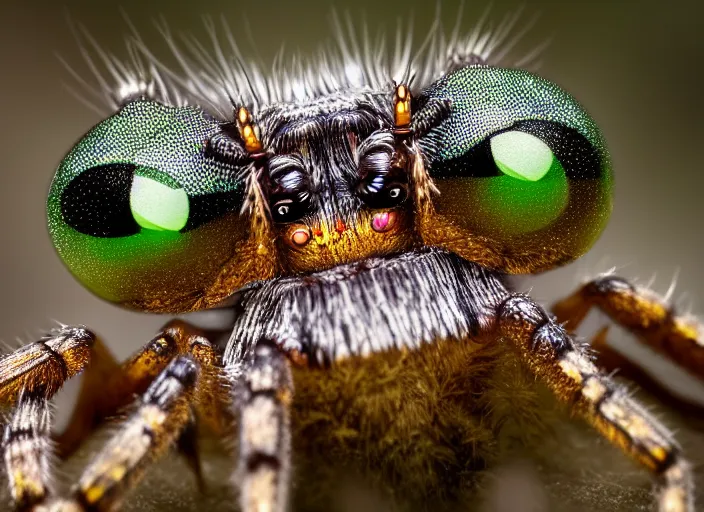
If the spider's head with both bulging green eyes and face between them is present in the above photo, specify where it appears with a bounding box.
[49,65,611,311]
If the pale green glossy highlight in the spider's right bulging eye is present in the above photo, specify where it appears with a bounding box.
[490,130,555,181]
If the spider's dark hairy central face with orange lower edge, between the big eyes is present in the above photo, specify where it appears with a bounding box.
[264,101,419,273]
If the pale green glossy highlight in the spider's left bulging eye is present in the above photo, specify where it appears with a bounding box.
[130,175,189,231]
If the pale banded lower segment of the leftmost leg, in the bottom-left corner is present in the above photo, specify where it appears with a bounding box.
[2,393,51,510]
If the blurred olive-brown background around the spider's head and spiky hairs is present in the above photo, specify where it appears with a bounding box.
[0,0,704,412]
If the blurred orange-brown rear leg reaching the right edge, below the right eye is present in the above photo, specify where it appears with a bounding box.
[553,276,704,378]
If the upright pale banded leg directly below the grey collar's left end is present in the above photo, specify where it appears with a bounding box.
[238,341,293,512]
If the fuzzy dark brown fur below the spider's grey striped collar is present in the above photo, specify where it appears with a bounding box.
[292,340,547,510]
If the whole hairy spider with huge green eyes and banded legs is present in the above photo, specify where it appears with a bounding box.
[0,5,702,511]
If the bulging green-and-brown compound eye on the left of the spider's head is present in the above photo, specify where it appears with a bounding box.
[48,100,246,309]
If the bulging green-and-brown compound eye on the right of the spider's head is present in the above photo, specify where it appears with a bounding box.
[420,66,612,272]
